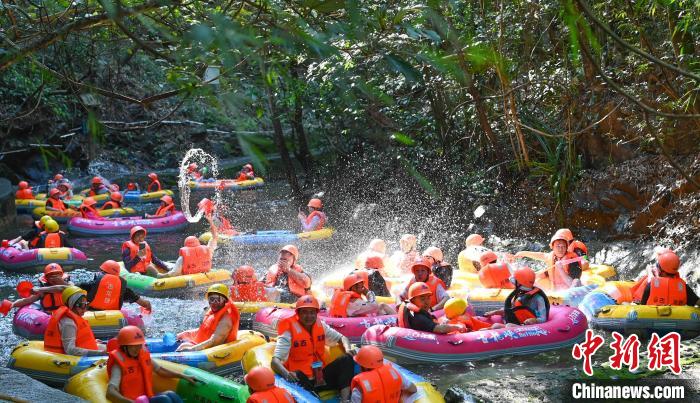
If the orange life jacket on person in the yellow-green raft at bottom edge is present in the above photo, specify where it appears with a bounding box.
[107,348,154,400]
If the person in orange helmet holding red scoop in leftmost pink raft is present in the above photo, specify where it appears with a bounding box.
[10,263,73,313]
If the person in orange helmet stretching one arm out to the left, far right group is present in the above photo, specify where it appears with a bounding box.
[515,228,588,291]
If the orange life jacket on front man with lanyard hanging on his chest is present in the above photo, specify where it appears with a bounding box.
[277,315,326,379]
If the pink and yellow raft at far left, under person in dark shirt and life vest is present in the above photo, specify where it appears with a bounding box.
[12,304,144,340]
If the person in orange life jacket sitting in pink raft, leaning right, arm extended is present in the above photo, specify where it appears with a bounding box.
[330,274,396,318]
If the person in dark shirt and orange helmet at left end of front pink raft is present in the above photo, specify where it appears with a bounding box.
[398,282,464,334]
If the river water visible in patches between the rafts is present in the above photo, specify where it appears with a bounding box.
[0,182,700,401]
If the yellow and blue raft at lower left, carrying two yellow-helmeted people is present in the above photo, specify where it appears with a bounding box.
[8,330,265,385]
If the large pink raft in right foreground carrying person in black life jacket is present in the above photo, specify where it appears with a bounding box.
[362,306,588,363]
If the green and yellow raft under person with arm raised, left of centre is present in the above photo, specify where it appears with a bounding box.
[119,262,231,297]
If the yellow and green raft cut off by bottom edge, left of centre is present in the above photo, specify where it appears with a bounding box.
[65,359,249,403]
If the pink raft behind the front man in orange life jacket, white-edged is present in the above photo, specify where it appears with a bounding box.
[253,307,398,343]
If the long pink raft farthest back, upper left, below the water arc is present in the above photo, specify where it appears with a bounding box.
[68,211,187,236]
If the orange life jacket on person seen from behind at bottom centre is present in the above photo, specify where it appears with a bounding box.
[350,363,401,403]
